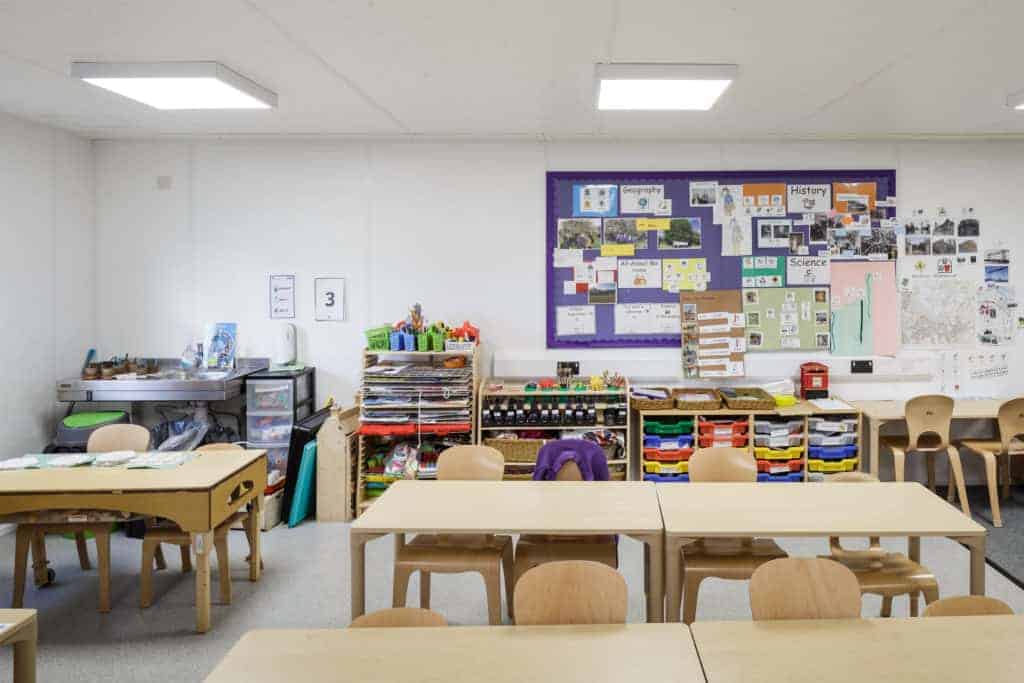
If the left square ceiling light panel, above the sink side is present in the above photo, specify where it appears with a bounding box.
[71,61,278,110]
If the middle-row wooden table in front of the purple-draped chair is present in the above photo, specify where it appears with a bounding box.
[349,481,665,622]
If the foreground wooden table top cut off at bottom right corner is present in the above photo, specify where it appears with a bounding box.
[690,616,1024,683]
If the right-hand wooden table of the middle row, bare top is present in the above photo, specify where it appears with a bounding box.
[657,481,985,622]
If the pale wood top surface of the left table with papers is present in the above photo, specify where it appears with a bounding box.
[0,450,266,496]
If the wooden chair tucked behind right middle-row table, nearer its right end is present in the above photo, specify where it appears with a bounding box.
[825,472,939,616]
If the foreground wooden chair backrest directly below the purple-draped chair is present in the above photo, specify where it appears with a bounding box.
[513,560,628,626]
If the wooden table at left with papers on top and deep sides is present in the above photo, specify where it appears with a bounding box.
[0,451,266,633]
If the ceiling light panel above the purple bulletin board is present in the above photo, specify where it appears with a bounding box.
[597,63,738,112]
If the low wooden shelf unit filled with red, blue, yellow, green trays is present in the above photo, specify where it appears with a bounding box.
[637,401,863,483]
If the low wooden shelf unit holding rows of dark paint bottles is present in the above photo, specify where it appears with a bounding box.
[476,377,632,481]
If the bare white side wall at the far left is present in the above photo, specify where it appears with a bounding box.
[0,115,95,458]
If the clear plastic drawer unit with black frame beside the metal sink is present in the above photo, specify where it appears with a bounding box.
[245,368,316,483]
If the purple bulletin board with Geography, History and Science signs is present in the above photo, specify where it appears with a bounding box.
[545,165,896,350]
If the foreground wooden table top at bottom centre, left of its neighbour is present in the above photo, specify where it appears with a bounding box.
[206,626,705,683]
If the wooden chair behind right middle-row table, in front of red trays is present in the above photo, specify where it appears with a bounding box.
[669,447,787,624]
